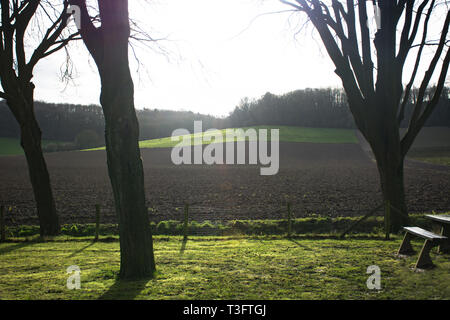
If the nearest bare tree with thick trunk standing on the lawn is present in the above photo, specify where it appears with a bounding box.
[70,0,155,278]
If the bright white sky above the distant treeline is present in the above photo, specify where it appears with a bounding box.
[34,0,446,116]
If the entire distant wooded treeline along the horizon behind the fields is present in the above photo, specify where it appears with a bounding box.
[0,88,450,149]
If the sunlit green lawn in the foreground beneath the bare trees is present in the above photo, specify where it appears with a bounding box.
[0,236,450,299]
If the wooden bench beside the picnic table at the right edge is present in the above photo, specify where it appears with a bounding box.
[398,227,447,269]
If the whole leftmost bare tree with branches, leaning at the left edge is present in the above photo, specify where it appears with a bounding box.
[0,0,77,236]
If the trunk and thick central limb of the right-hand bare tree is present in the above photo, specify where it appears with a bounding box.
[369,1,408,232]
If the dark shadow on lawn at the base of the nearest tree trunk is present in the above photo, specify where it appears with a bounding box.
[98,277,153,300]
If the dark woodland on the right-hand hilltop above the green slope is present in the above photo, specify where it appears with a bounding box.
[225,88,450,128]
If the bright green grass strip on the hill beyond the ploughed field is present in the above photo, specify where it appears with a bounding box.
[88,126,358,151]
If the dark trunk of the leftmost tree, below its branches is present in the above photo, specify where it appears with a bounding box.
[8,96,60,236]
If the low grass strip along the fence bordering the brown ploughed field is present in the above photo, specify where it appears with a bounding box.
[6,213,442,237]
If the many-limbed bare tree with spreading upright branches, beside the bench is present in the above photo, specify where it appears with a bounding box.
[280,0,450,231]
